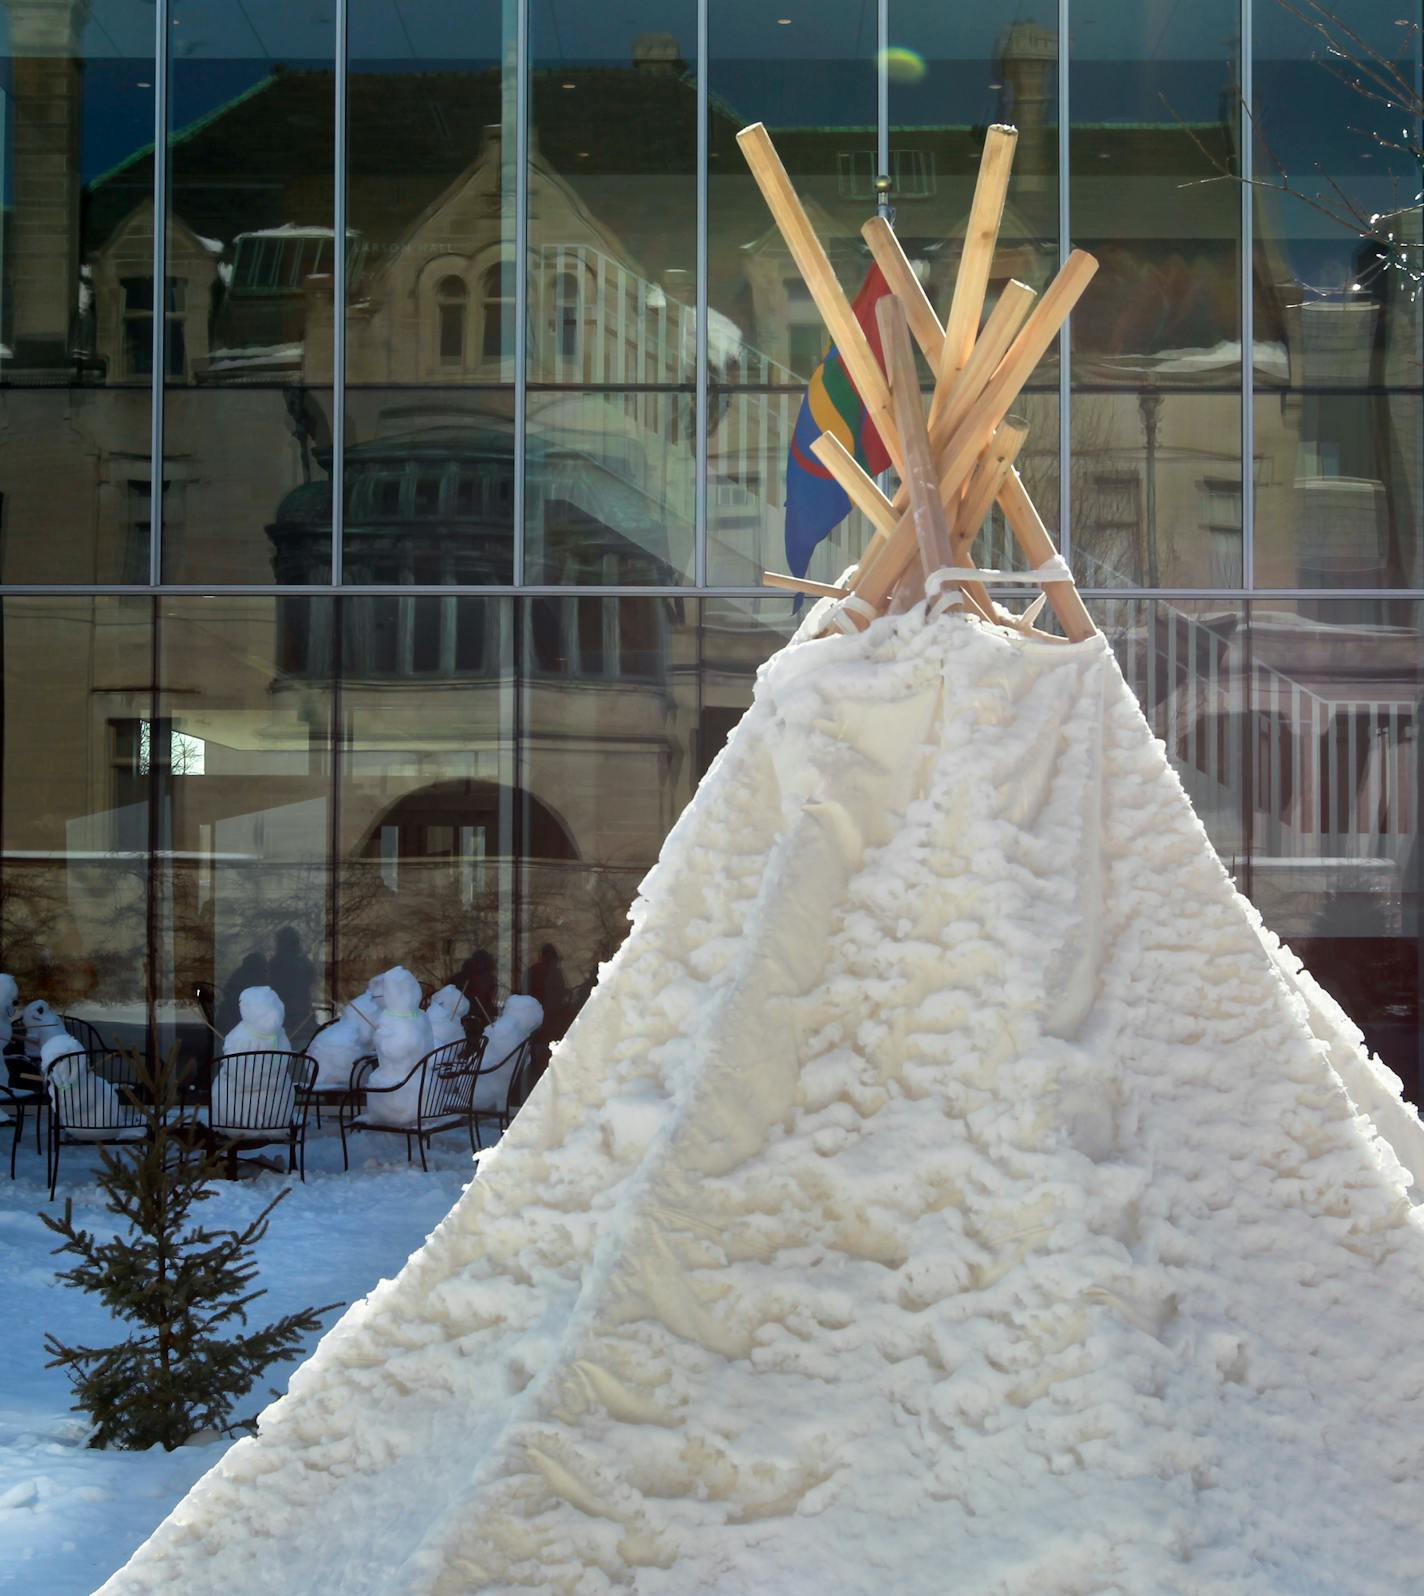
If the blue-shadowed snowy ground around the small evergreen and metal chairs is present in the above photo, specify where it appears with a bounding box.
[0,1125,471,1596]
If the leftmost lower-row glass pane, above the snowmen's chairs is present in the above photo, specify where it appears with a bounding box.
[0,599,153,1044]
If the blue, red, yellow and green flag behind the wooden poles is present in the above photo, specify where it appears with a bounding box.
[785,267,889,576]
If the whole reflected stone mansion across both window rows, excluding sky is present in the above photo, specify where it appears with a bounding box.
[0,0,1421,1085]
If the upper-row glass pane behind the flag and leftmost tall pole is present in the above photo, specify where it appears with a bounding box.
[707,0,876,586]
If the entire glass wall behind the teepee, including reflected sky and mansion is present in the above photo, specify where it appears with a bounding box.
[0,0,1424,1082]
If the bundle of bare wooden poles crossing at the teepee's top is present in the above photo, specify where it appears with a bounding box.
[738,123,1097,642]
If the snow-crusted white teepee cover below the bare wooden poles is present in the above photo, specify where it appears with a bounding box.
[104,127,1424,1596]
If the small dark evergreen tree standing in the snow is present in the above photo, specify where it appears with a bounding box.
[40,1053,340,1451]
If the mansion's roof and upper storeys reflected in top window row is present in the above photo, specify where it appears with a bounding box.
[0,17,1421,587]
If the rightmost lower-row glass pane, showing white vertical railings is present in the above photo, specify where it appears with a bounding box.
[1250,599,1424,1101]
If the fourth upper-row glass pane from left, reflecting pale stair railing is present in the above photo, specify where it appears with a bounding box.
[525,0,698,583]
